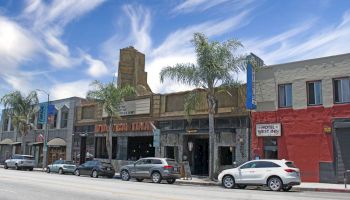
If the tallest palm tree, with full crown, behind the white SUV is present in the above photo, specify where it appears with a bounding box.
[160,33,245,179]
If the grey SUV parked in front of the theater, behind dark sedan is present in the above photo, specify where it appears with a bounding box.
[120,158,180,184]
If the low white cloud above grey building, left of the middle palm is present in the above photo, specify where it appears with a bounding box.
[50,79,92,100]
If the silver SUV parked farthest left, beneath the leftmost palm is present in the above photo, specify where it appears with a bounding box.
[4,154,35,171]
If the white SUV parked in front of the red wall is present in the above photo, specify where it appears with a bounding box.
[218,160,301,191]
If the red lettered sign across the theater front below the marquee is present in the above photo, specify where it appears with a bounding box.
[95,121,153,133]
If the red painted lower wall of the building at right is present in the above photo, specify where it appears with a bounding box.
[252,104,350,182]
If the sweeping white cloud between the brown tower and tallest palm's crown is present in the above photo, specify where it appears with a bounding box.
[146,10,250,92]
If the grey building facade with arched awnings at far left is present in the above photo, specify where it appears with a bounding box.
[0,97,81,167]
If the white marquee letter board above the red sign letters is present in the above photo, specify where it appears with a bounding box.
[102,98,151,117]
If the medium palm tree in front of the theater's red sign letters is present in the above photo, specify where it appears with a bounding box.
[87,81,135,161]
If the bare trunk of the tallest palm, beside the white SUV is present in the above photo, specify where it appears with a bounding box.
[208,95,216,180]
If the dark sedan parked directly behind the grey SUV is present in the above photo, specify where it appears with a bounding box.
[74,160,115,178]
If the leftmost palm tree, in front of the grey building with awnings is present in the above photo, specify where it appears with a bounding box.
[0,91,39,154]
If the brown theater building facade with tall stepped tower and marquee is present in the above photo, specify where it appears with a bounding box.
[73,47,250,175]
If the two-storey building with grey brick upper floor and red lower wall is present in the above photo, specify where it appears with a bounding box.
[252,54,350,182]
